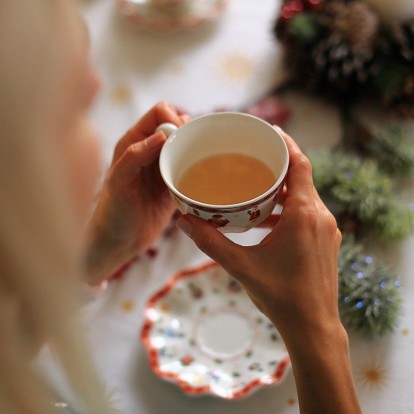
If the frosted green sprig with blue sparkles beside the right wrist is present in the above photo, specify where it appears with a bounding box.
[339,236,402,339]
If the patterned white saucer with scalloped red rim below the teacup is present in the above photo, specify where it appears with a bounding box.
[141,262,290,399]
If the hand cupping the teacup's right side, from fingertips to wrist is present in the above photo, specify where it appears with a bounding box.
[177,130,341,342]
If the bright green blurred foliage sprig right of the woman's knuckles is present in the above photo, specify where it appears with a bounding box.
[310,150,413,240]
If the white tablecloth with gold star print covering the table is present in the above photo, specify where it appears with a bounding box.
[38,0,414,414]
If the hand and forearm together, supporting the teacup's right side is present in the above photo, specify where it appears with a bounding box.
[177,129,361,414]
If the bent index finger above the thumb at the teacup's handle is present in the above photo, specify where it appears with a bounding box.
[114,101,184,162]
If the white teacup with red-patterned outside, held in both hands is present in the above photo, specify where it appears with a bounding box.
[157,112,289,233]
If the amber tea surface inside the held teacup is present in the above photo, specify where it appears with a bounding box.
[177,154,276,205]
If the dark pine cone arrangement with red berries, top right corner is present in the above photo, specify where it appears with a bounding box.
[274,0,414,118]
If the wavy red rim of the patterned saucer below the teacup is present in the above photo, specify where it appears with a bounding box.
[141,261,290,400]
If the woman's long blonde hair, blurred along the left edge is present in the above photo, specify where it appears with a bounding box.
[0,0,106,414]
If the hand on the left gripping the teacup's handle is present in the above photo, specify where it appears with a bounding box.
[87,102,189,284]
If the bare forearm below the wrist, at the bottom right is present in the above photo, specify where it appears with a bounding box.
[287,324,361,414]
